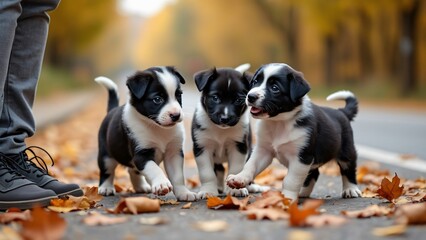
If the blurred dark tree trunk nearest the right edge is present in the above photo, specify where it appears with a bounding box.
[400,0,420,95]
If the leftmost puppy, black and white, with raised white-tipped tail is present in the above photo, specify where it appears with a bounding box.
[95,67,196,201]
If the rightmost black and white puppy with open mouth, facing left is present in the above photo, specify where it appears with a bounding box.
[227,63,361,201]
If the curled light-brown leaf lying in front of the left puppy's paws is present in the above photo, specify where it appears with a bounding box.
[113,197,160,214]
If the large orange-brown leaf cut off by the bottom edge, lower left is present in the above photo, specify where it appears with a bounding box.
[20,207,67,240]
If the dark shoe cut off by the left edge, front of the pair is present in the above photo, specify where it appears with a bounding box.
[0,158,57,210]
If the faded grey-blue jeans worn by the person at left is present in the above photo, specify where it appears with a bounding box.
[0,0,60,154]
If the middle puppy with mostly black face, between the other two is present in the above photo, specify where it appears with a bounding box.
[191,64,262,199]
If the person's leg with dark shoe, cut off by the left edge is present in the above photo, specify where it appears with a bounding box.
[0,0,56,210]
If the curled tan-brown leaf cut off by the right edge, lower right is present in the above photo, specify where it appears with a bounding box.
[395,202,426,224]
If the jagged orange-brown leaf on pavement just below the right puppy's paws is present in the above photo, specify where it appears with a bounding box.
[288,199,324,227]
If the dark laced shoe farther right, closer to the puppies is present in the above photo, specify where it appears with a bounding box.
[4,146,83,197]
